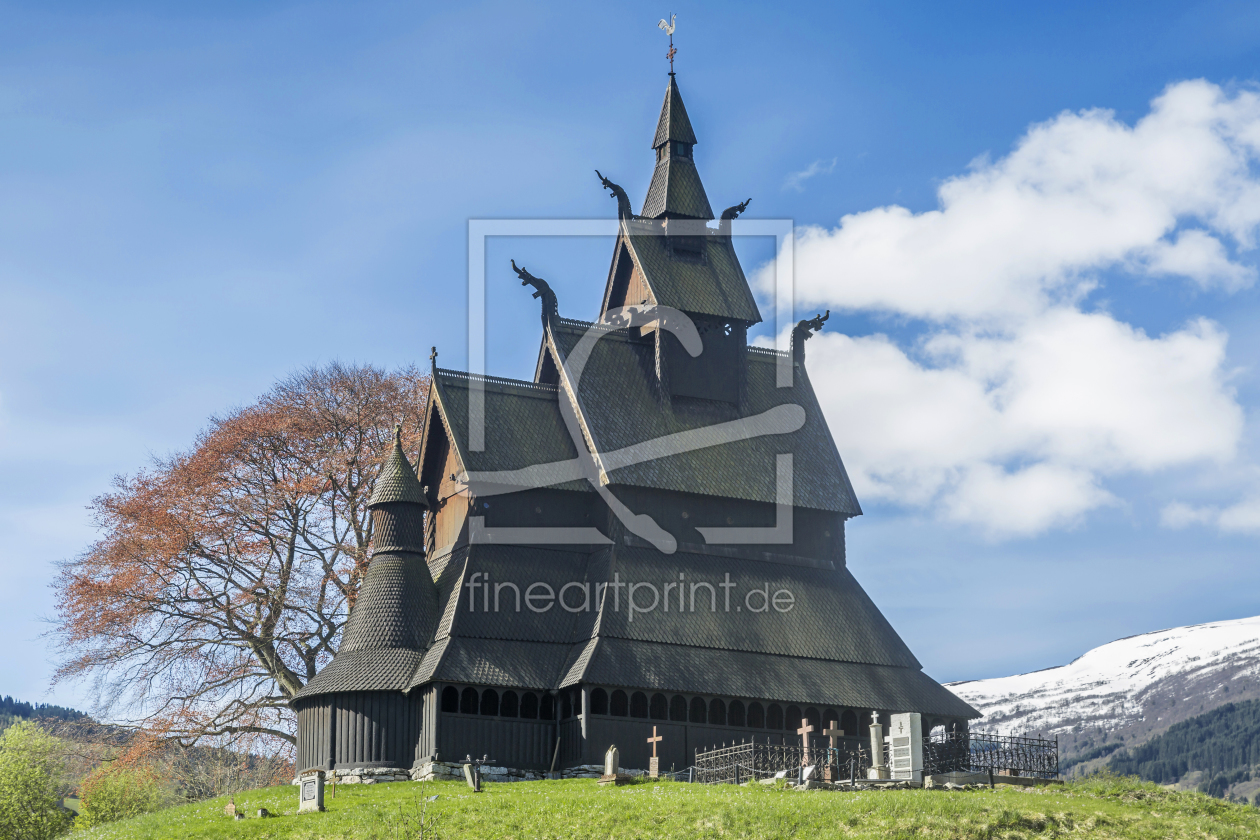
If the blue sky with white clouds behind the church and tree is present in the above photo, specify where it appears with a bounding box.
[0,3,1260,705]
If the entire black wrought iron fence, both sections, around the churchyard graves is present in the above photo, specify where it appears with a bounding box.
[689,732,1058,785]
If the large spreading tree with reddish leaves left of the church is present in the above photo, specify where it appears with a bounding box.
[54,364,428,744]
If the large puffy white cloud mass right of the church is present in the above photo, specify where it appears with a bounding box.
[760,82,1260,534]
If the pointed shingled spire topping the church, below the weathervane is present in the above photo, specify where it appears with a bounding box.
[640,73,713,220]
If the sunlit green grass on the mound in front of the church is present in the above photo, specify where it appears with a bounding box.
[71,777,1260,840]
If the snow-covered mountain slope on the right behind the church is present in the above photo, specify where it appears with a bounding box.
[949,616,1260,758]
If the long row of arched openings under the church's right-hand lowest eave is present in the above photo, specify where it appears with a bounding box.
[591,689,858,735]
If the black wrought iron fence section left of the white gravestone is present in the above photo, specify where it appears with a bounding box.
[694,738,871,785]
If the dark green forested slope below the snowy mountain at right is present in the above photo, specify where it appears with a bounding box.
[1109,700,1260,796]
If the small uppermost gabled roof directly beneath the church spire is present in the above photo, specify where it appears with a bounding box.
[621,219,761,324]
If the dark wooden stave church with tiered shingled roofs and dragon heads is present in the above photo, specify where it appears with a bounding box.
[294,73,979,772]
